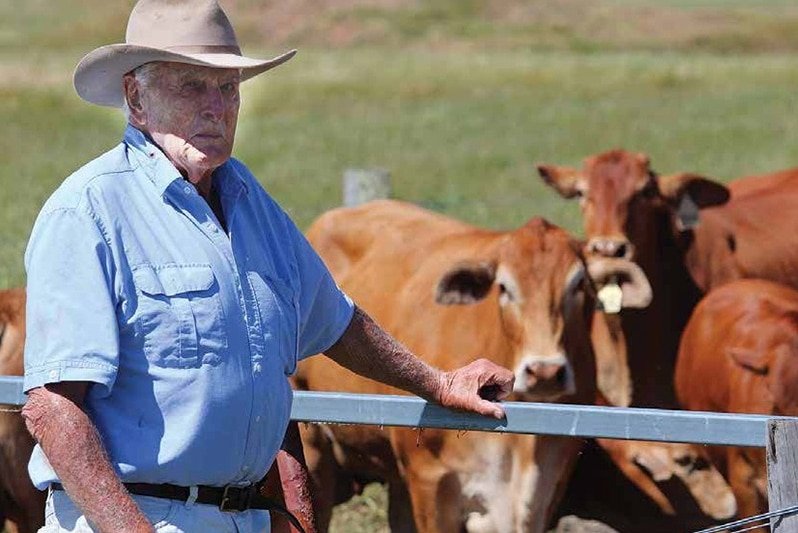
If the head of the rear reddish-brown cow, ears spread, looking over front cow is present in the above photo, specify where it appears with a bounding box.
[537,150,729,259]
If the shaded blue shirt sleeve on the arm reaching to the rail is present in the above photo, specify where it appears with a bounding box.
[288,214,355,359]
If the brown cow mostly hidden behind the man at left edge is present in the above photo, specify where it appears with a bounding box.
[0,288,46,533]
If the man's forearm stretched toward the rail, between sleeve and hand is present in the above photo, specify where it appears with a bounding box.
[325,307,446,401]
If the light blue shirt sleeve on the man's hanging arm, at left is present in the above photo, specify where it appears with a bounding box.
[24,208,119,396]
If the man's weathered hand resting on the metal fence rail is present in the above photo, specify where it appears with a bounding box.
[437,359,515,419]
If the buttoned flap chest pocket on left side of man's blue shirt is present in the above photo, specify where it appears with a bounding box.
[133,263,227,368]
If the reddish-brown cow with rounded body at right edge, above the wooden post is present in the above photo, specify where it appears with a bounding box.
[675,279,798,516]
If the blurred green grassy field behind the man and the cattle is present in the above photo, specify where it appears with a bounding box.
[0,0,798,533]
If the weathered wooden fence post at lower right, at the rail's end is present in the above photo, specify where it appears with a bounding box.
[767,420,798,533]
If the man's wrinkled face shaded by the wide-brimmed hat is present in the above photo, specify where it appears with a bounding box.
[135,63,241,183]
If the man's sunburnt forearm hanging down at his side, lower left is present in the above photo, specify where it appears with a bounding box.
[23,387,154,533]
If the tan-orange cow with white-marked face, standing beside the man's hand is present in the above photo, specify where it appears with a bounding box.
[296,201,650,533]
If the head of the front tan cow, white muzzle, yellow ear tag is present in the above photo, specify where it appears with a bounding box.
[435,218,651,402]
